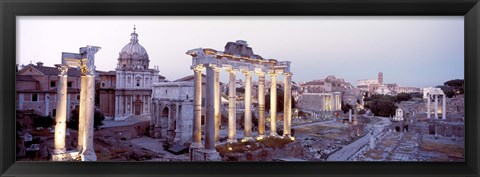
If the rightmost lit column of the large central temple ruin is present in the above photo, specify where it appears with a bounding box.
[283,73,292,137]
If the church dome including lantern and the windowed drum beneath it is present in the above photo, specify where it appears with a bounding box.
[118,28,150,69]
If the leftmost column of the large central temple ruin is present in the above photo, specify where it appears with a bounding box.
[190,65,204,149]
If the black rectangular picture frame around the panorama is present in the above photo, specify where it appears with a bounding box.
[0,0,480,176]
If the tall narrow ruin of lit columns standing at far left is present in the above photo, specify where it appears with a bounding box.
[52,46,100,161]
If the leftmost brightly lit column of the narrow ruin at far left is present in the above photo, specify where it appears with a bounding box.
[54,65,68,160]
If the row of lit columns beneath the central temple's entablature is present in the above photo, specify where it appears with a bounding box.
[191,64,292,149]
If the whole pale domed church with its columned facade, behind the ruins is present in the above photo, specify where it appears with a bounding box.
[115,28,164,120]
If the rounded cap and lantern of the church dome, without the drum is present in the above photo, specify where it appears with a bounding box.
[120,27,148,60]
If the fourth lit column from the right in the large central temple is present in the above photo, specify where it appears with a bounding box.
[243,70,253,141]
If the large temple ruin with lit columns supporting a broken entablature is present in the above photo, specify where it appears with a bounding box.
[187,40,293,161]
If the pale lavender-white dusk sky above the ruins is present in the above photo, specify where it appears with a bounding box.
[16,16,464,87]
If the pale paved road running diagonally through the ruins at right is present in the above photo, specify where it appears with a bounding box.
[327,117,391,161]
